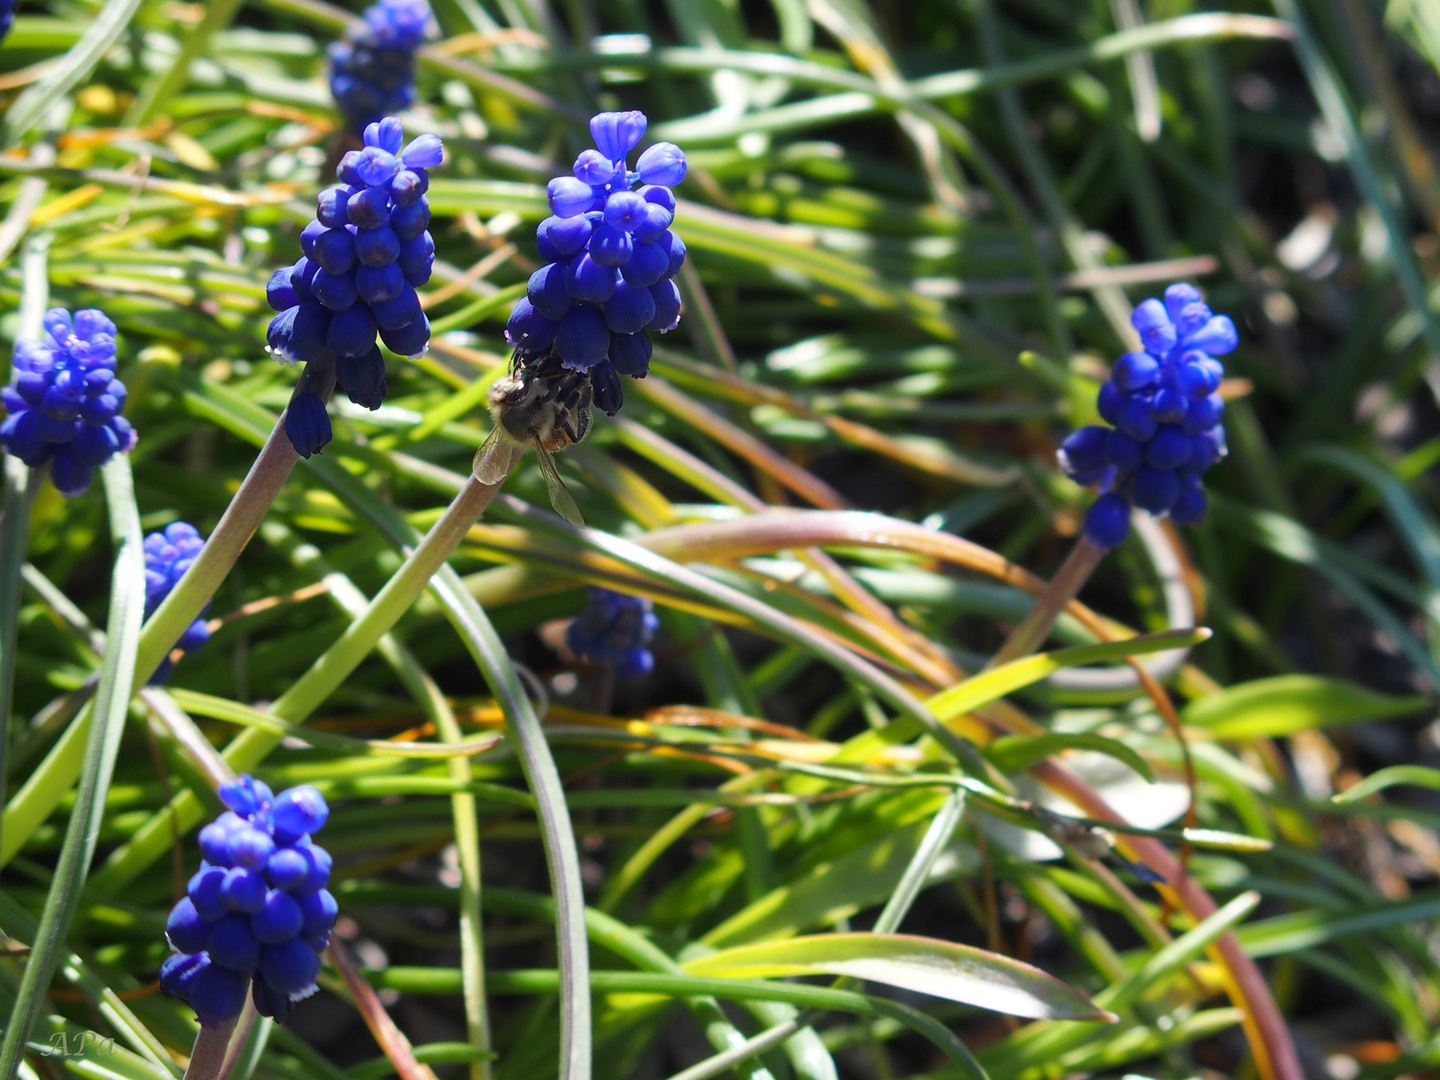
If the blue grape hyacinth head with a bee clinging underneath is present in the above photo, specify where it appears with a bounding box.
[505,112,685,416]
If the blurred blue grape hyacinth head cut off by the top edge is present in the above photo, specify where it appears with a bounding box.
[330,0,431,135]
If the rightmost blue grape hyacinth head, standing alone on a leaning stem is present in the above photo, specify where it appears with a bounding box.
[1057,284,1238,547]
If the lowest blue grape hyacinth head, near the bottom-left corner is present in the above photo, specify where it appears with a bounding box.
[160,776,337,1027]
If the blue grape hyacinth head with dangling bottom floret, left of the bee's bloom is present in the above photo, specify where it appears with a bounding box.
[266,117,444,458]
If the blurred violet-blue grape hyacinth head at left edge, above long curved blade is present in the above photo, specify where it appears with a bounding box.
[0,308,135,495]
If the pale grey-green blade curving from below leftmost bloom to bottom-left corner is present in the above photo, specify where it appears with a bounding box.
[0,454,145,1080]
